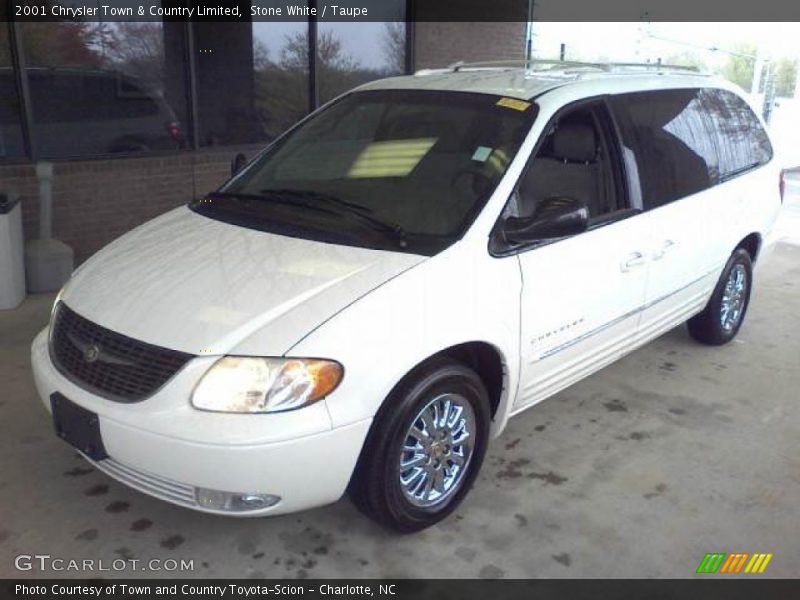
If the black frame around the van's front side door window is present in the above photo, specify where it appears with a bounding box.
[489,92,644,258]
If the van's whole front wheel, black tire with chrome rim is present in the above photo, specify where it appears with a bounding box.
[349,358,491,533]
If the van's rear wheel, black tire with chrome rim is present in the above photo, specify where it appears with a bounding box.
[688,248,753,346]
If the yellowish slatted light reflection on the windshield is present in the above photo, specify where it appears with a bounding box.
[347,138,437,179]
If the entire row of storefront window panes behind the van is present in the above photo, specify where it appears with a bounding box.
[0,13,407,159]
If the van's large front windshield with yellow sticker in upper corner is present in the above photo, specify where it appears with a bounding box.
[192,90,536,254]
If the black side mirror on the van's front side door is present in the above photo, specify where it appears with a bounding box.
[503,196,589,244]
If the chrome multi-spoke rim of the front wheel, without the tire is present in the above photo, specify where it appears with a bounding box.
[399,394,476,508]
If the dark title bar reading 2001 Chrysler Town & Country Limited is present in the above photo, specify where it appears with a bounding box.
[0,0,800,23]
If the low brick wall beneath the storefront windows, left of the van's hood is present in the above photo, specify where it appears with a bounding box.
[0,147,257,264]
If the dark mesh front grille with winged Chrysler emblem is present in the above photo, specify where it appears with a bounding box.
[50,302,192,402]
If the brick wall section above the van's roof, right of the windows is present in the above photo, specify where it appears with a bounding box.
[414,22,526,69]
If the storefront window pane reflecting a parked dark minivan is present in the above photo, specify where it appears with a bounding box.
[18,17,189,158]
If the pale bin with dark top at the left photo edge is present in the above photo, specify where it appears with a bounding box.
[0,192,25,310]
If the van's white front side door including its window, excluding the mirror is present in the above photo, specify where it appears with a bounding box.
[507,100,651,410]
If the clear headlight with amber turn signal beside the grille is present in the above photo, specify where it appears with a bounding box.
[192,356,344,413]
